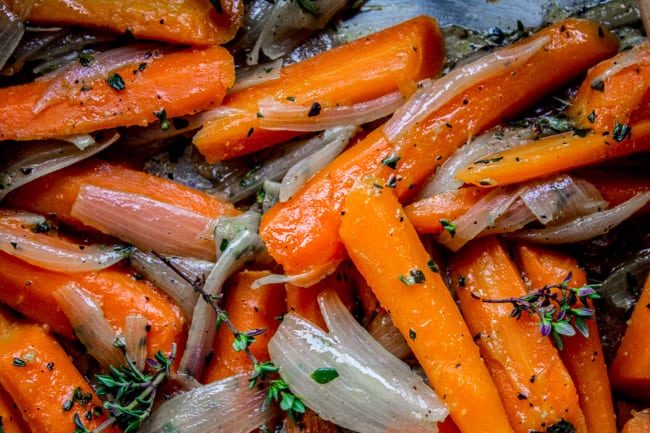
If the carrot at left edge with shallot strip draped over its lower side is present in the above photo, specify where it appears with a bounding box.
[0,253,185,357]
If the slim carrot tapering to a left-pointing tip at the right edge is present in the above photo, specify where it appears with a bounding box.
[456,119,650,186]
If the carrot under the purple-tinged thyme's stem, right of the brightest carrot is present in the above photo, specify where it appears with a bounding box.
[450,236,587,433]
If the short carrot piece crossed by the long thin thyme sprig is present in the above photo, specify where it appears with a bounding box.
[201,271,286,383]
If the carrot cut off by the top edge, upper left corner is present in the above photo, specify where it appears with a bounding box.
[8,0,244,46]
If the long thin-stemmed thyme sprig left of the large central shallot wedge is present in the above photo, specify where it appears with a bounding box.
[153,252,307,423]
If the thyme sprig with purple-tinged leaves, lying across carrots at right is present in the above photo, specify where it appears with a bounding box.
[483,272,600,350]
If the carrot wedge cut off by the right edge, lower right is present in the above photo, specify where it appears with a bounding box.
[609,272,650,403]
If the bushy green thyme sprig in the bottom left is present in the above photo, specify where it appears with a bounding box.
[88,340,176,433]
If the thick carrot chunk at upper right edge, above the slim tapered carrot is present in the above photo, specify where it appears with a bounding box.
[566,42,650,131]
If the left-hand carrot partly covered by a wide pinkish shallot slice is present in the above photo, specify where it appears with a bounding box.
[4,159,239,229]
